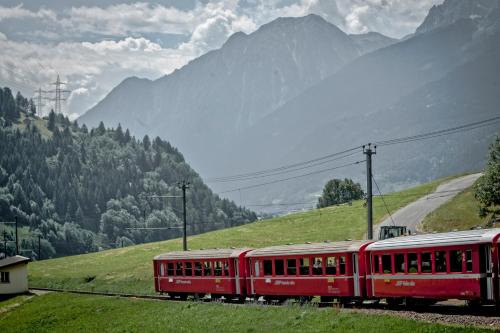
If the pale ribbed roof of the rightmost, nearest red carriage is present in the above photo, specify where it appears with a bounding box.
[366,228,500,251]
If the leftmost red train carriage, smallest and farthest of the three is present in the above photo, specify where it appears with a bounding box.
[154,249,250,299]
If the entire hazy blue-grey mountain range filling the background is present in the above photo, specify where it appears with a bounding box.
[79,0,500,211]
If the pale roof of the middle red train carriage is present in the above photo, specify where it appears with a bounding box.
[246,241,370,257]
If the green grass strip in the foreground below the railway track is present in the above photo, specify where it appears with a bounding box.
[0,293,491,333]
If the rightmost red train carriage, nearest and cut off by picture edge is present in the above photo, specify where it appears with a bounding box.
[366,229,500,304]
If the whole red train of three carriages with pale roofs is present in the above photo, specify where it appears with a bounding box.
[154,229,500,305]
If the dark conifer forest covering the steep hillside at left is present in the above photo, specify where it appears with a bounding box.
[0,88,256,258]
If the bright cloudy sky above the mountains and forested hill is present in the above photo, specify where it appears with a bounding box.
[0,0,443,118]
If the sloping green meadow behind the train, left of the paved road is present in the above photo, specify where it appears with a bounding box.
[29,175,456,293]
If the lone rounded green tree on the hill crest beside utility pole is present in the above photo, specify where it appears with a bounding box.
[317,178,364,208]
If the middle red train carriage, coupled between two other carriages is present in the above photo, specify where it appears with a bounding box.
[246,241,370,301]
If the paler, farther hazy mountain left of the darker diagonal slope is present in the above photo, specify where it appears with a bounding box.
[79,15,393,182]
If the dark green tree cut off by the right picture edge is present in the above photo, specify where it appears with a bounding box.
[474,136,500,217]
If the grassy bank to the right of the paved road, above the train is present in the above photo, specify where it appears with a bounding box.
[422,180,490,232]
